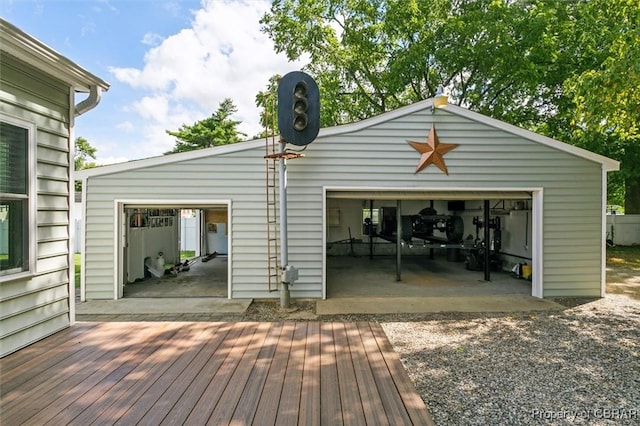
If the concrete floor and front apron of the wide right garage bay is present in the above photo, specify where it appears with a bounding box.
[316,256,563,315]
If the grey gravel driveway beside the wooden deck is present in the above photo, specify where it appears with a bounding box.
[383,295,640,425]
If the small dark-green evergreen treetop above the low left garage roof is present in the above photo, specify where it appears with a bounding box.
[165,98,246,154]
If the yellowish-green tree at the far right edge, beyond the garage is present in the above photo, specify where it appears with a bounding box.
[565,0,640,214]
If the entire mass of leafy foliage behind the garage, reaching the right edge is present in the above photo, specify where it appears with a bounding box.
[261,0,640,210]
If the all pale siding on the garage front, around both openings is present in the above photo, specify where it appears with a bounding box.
[85,106,603,299]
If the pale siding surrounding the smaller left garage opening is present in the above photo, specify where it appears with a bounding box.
[84,150,268,299]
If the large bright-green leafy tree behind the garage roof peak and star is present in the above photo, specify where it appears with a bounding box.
[261,0,562,125]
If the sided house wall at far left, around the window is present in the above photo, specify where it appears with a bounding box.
[0,52,71,356]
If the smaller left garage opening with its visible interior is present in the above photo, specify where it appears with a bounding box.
[118,204,229,298]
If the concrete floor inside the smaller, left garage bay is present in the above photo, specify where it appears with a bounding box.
[124,255,228,298]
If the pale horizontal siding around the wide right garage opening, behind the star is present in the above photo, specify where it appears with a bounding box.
[296,109,604,297]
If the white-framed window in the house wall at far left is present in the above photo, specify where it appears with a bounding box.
[0,116,35,279]
